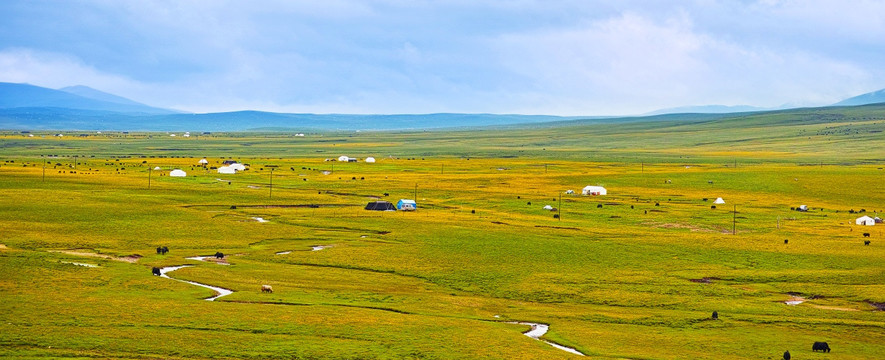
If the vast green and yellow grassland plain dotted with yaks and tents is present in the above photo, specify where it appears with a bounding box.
[0,106,885,360]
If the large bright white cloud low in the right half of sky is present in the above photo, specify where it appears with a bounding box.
[495,13,871,114]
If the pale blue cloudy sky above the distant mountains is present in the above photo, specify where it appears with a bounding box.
[0,0,885,115]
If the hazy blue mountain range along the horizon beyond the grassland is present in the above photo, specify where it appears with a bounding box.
[0,82,885,131]
